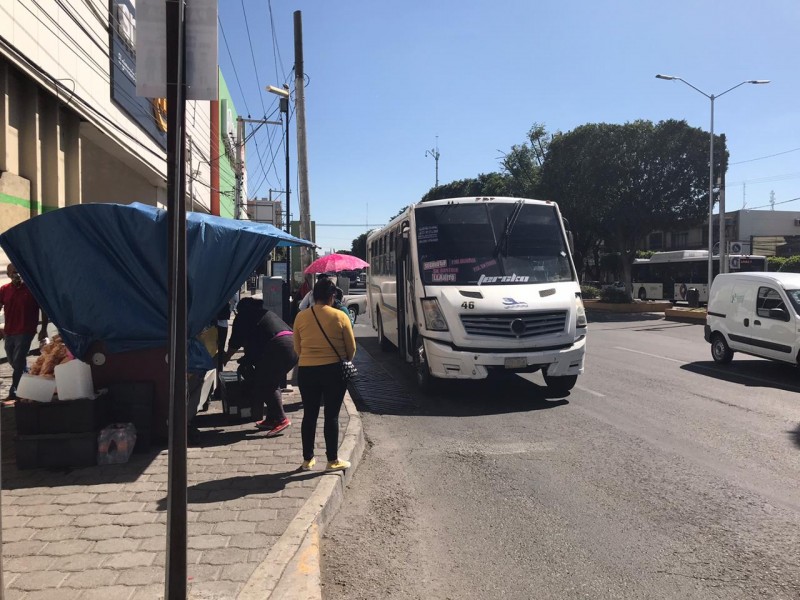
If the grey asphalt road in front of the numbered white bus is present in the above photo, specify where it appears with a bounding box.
[321,315,800,600]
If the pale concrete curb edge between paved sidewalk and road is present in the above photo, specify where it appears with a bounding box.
[236,391,366,600]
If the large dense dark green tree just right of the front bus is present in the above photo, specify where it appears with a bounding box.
[541,120,728,289]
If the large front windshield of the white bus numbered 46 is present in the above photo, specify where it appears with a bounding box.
[416,202,575,285]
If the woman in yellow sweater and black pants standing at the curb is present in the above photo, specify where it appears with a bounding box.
[294,279,356,471]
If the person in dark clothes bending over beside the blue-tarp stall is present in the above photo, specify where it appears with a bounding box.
[225,298,297,437]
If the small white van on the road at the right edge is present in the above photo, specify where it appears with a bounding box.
[704,273,800,365]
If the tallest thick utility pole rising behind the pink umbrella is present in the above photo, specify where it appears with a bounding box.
[294,10,312,273]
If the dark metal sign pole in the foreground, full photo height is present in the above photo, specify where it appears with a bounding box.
[165,0,187,600]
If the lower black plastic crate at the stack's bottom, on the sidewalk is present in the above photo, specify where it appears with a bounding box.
[16,432,97,469]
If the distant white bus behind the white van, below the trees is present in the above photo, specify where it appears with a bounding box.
[631,250,767,304]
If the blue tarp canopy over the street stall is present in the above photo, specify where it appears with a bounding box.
[0,202,313,370]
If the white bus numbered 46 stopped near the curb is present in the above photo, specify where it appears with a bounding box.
[367,197,587,393]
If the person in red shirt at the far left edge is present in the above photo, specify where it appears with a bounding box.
[0,263,48,399]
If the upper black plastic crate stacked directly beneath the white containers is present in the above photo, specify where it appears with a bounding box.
[14,394,109,435]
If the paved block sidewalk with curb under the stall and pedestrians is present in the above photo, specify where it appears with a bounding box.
[0,354,364,600]
